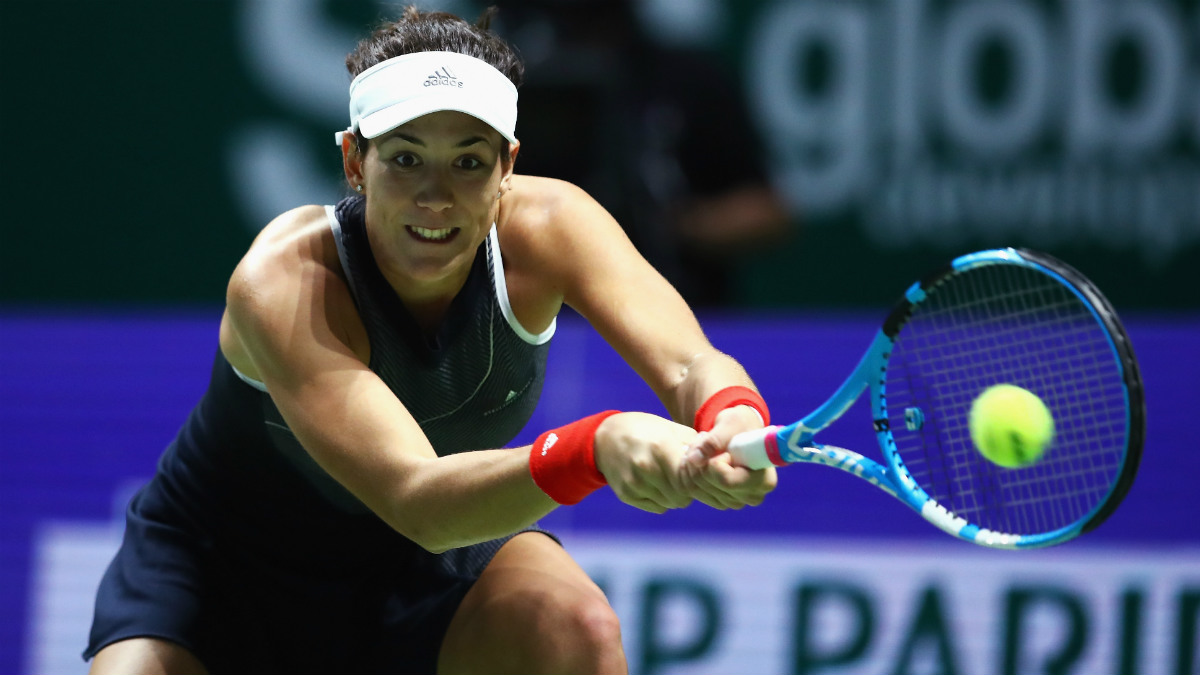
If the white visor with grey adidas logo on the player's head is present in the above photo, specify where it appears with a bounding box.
[337,52,517,143]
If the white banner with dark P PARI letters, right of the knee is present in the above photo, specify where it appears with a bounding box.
[565,534,1200,675]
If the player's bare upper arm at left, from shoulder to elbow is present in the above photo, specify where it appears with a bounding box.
[227,212,436,528]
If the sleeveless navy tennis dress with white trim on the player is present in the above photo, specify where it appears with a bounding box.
[84,197,554,673]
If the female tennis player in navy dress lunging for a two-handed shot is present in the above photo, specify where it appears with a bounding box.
[84,7,776,675]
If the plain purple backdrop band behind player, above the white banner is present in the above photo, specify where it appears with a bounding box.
[0,310,1200,673]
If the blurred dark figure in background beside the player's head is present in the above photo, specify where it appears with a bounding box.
[498,0,791,306]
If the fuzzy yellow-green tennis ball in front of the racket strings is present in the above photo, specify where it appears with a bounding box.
[968,384,1054,468]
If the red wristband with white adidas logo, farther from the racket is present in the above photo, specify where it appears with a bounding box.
[529,410,620,504]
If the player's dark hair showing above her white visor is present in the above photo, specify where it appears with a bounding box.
[346,5,524,154]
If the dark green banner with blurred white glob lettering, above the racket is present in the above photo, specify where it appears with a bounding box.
[737,0,1200,306]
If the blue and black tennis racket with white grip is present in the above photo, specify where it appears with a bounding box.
[728,249,1145,549]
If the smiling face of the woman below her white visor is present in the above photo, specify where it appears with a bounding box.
[350,110,512,291]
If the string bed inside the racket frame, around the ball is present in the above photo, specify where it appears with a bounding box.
[887,265,1128,533]
